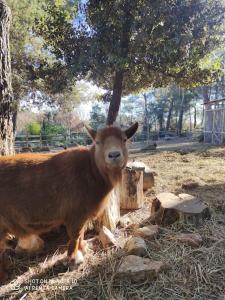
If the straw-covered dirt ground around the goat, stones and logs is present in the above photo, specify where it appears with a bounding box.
[0,143,225,300]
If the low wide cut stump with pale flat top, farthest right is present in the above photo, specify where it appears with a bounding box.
[150,193,210,226]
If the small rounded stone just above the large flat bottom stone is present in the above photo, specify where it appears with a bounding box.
[124,237,147,256]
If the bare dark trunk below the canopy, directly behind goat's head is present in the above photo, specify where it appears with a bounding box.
[106,71,123,125]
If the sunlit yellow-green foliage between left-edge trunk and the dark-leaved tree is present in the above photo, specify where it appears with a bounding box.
[7,0,76,100]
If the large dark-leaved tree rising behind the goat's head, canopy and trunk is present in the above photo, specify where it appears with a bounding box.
[38,0,224,124]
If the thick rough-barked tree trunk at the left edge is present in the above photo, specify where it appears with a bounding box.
[0,0,14,155]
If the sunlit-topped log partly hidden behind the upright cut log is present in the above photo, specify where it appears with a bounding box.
[127,161,155,191]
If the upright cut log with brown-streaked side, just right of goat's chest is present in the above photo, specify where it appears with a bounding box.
[120,167,144,209]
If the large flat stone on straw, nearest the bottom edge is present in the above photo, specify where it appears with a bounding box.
[117,255,168,282]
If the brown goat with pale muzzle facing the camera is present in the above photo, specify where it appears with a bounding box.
[0,123,138,277]
